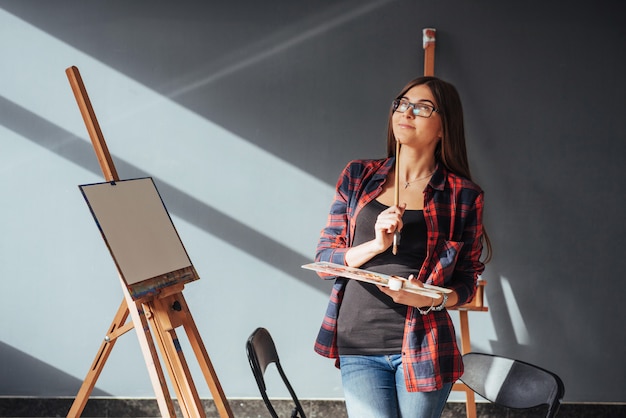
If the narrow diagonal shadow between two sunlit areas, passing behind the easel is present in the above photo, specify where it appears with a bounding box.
[0,97,330,294]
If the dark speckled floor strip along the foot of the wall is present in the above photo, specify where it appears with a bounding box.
[0,398,626,418]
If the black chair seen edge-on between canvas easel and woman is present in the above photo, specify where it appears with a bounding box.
[246,328,306,418]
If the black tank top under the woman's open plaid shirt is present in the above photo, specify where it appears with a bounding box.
[337,200,427,355]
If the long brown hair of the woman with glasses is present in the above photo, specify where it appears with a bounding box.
[387,77,492,263]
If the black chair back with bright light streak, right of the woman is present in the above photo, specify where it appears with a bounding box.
[460,353,565,418]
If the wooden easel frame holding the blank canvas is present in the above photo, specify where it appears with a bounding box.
[65,67,233,418]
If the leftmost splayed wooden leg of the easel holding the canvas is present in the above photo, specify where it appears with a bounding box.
[67,301,128,418]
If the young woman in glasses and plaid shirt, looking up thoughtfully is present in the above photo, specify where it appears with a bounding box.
[315,77,491,418]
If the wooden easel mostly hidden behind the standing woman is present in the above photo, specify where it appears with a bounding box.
[422,28,489,418]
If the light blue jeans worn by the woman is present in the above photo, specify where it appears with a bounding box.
[339,354,452,418]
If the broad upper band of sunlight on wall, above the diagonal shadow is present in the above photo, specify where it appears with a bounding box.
[0,9,333,258]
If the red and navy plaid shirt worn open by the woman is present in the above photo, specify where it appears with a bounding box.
[315,158,484,392]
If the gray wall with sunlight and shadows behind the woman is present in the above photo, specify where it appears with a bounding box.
[0,0,626,402]
